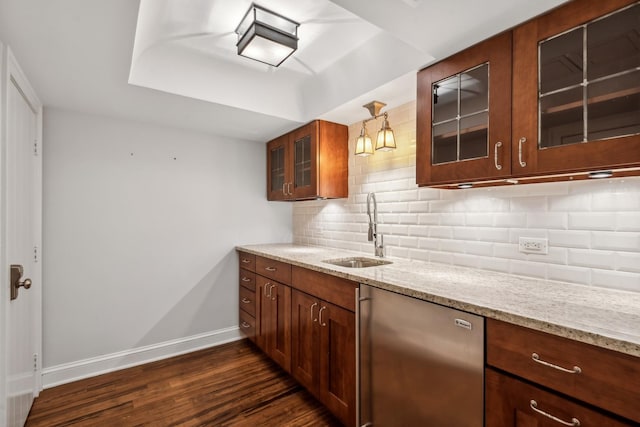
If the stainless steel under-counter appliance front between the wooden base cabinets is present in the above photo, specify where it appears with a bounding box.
[358,285,484,427]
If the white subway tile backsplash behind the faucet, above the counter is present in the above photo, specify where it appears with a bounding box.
[293,102,640,292]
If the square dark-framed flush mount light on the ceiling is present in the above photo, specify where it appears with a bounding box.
[236,4,300,67]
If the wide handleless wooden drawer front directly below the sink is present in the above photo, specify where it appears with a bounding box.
[291,266,358,311]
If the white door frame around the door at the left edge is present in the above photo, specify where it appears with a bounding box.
[0,41,42,423]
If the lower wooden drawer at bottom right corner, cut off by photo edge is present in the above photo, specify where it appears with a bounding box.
[485,369,633,427]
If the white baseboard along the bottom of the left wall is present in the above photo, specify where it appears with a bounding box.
[42,326,243,388]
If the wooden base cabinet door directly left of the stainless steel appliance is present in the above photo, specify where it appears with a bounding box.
[318,301,356,425]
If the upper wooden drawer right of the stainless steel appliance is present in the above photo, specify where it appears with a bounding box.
[486,319,640,422]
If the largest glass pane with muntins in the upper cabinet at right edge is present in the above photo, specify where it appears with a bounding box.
[538,4,640,149]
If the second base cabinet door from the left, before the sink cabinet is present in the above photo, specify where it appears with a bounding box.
[268,283,291,372]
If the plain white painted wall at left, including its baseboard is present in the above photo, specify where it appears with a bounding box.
[43,108,291,385]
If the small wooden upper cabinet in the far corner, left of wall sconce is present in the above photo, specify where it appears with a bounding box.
[267,120,348,200]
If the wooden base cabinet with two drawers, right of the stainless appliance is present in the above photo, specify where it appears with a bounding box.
[485,319,640,427]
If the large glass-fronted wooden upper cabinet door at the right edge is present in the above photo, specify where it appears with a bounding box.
[512,0,640,176]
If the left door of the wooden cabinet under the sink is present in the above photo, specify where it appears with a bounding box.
[291,290,320,397]
